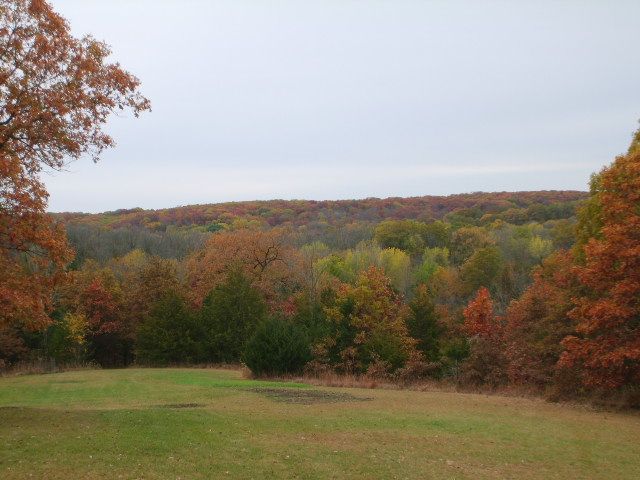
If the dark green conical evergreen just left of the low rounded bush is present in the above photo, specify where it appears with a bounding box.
[201,269,267,363]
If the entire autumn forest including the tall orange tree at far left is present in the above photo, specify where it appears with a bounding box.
[0,0,640,406]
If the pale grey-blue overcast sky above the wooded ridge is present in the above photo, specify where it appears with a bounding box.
[43,0,640,212]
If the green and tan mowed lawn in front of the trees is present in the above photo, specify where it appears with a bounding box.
[0,369,640,480]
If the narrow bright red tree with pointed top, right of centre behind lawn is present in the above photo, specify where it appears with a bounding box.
[462,287,506,387]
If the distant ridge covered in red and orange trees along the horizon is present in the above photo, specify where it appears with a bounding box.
[54,191,587,231]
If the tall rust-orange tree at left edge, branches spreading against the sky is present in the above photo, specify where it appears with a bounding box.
[0,0,149,328]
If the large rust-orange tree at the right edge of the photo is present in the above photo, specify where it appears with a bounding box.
[561,151,640,390]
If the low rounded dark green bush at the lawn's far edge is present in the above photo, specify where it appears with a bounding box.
[244,317,311,376]
